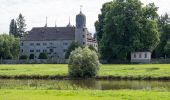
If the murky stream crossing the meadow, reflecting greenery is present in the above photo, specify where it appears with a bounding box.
[0,79,170,91]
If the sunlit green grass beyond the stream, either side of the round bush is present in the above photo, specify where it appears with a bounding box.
[0,64,170,78]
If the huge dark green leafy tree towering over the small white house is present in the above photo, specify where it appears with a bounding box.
[96,0,159,61]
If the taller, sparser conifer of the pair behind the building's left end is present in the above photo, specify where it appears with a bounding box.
[17,14,26,37]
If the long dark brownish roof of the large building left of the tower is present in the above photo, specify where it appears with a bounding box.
[22,27,75,41]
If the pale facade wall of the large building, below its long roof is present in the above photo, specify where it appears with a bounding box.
[20,40,73,59]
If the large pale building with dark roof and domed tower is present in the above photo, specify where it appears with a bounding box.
[20,11,98,59]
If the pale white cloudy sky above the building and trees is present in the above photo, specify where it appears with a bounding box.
[0,0,170,33]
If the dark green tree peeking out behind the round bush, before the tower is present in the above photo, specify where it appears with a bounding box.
[65,41,82,59]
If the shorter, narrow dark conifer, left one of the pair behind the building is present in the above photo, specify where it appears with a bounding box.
[9,19,18,37]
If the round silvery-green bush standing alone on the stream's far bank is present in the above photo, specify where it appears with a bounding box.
[68,47,100,78]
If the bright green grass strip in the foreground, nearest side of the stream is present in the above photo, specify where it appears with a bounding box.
[0,89,170,100]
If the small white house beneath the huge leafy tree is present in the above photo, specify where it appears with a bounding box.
[131,52,151,63]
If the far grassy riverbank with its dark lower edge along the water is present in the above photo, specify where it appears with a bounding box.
[0,64,170,80]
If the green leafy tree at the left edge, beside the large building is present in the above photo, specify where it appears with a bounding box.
[0,34,19,59]
